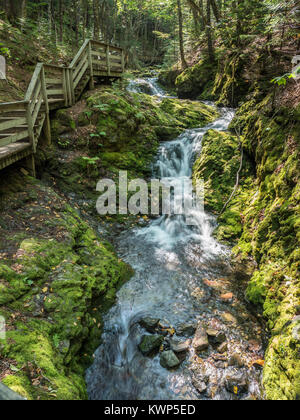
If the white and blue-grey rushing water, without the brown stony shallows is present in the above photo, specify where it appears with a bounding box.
[87,79,264,400]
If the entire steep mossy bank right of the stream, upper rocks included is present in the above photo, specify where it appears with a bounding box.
[176,57,300,400]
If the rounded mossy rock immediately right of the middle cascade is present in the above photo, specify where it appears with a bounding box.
[193,130,253,241]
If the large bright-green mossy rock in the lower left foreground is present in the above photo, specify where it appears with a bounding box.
[0,174,132,400]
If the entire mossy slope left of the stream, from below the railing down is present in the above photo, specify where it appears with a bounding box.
[0,86,218,400]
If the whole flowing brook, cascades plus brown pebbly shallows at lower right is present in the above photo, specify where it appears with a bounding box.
[87,79,264,400]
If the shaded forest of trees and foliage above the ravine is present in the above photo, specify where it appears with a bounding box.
[0,0,300,68]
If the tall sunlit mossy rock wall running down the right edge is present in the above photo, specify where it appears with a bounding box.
[233,96,300,400]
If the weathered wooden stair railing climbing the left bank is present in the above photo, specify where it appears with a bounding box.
[0,39,125,172]
